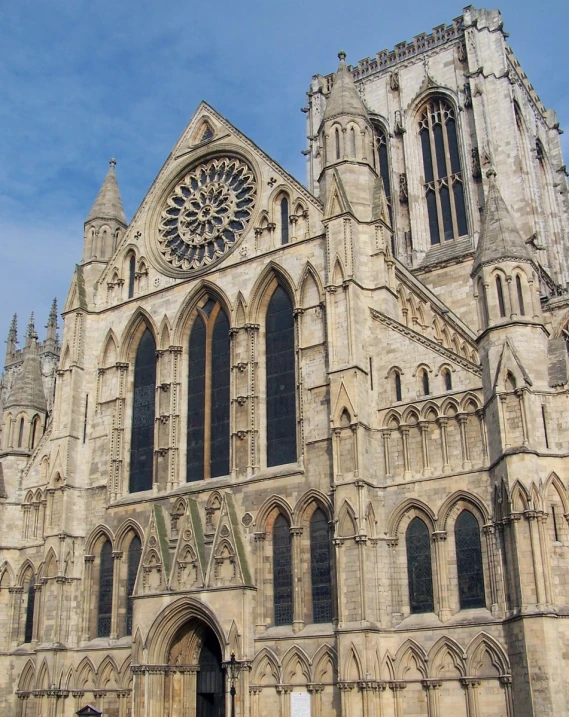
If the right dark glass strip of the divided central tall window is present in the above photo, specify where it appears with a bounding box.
[210,310,231,478]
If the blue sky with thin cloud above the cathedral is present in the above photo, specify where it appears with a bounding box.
[0,0,569,351]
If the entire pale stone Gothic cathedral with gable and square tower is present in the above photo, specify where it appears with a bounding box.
[0,7,569,717]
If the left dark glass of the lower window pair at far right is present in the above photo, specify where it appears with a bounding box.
[405,518,435,613]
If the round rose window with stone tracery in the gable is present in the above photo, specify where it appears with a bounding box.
[158,157,256,271]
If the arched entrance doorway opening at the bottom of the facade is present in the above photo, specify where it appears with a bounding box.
[165,618,225,717]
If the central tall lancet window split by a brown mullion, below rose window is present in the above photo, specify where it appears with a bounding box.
[186,299,231,482]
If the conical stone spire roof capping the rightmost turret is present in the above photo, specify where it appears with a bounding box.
[472,169,532,274]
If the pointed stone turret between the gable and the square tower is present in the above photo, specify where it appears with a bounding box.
[318,52,377,221]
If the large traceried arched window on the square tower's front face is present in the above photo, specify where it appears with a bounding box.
[419,97,468,244]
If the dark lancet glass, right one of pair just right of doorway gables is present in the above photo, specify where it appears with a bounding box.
[310,508,332,622]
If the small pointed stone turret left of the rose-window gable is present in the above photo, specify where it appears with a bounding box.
[82,159,127,264]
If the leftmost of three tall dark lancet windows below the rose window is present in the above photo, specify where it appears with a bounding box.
[129,329,156,493]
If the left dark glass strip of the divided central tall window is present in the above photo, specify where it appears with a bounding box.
[186,314,206,482]
